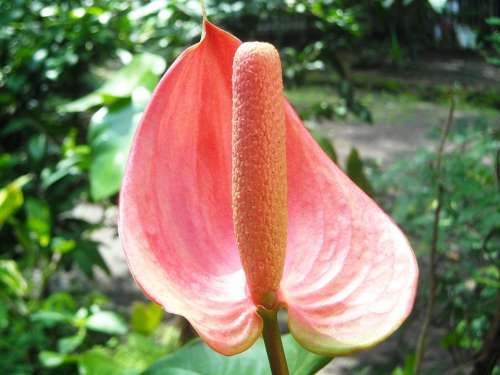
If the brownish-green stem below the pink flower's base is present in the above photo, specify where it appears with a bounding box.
[259,308,288,375]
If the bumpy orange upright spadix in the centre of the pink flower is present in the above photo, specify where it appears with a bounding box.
[232,42,287,309]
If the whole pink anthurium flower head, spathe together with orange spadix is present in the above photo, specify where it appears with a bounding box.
[119,21,418,355]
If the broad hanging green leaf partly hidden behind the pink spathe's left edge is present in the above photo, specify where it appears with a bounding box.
[89,104,143,201]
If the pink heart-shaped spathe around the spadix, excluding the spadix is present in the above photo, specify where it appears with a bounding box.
[119,22,418,354]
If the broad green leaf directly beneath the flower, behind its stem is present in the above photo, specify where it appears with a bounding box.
[142,334,331,375]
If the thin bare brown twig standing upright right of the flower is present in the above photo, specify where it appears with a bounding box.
[413,94,455,375]
